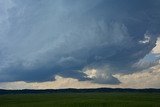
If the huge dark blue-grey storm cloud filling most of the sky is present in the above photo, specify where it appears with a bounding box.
[0,0,160,84]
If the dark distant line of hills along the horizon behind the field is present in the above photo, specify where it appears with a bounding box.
[0,88,160,95]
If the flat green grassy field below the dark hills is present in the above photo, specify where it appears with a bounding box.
[0,92,160,107]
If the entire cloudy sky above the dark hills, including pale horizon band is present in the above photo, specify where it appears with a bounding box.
[0,0,160,89]
